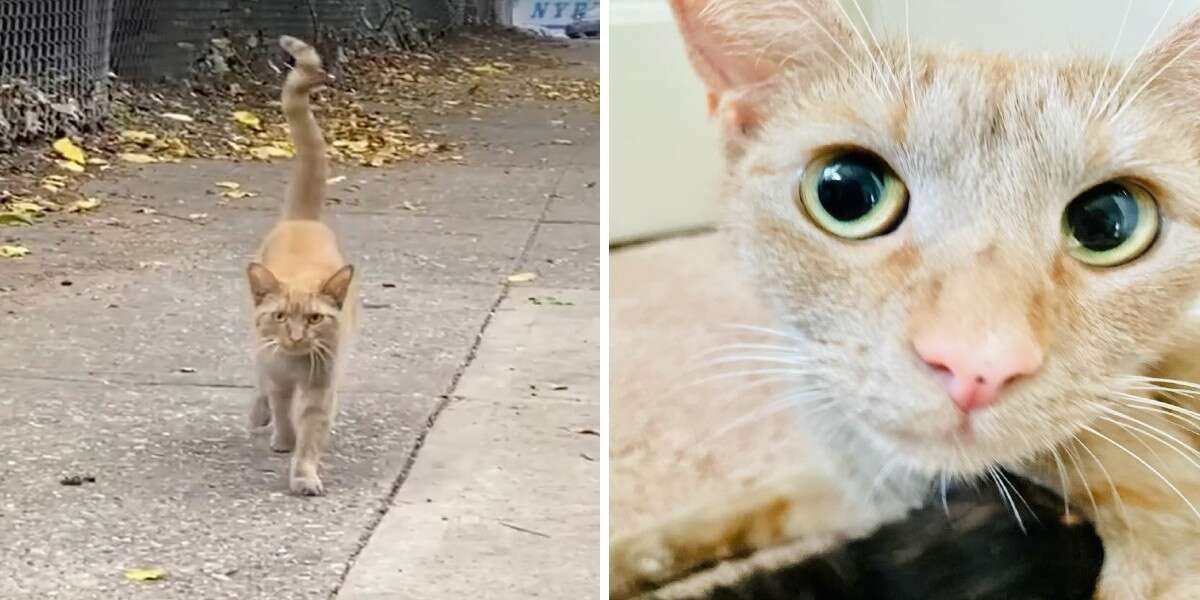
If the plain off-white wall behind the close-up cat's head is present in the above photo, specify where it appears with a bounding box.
[607,0,1200,242]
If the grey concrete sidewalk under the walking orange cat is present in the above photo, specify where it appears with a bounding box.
[0,38,600,599]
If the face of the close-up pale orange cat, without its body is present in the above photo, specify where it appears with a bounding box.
[700,2,1200,474]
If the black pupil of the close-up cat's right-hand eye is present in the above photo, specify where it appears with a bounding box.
[1067,184,1139,252]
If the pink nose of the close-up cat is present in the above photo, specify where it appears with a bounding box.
[913,332,1042,413]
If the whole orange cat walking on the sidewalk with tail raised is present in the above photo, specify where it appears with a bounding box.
[246,36,358,496]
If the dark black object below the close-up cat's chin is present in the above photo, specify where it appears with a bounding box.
[704,474,1104,600]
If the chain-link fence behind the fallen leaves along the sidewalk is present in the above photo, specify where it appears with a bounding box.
[0,0,477,150]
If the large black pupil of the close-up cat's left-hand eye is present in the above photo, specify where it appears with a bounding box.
[817,154,884,222]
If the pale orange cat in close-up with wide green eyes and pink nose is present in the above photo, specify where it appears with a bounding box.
[610,0,1200,600]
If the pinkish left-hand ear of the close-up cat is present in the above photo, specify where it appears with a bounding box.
[671,0,854,139]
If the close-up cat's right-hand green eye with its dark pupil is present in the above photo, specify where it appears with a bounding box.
[1062,180,1159,266]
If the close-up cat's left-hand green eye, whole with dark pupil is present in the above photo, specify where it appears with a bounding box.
[797,150,908,240]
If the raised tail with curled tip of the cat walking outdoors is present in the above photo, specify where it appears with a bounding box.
[280,36,332,221]
